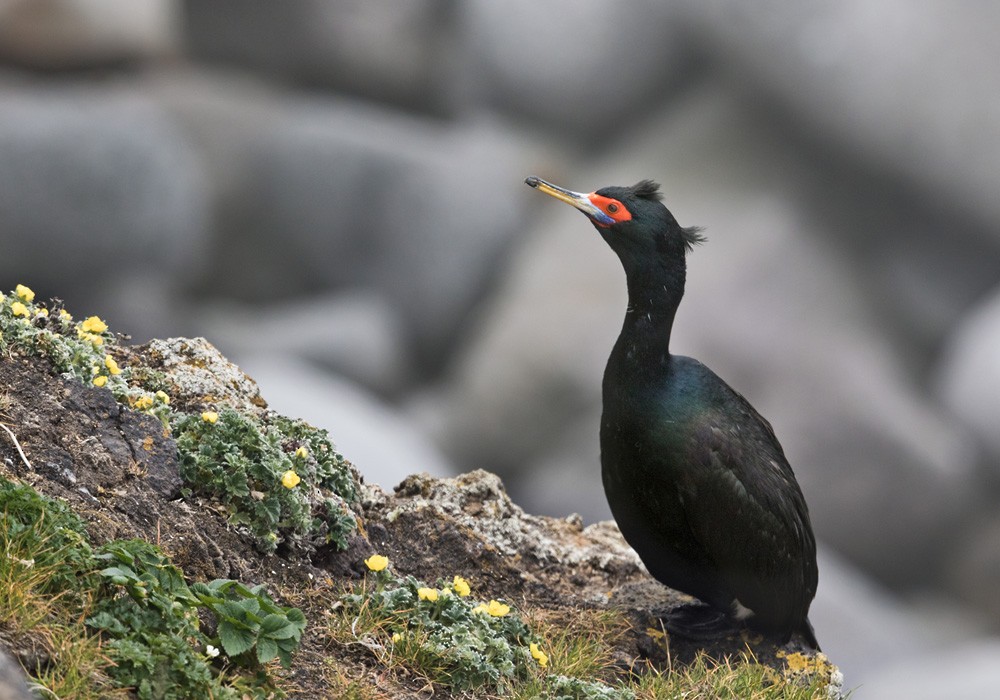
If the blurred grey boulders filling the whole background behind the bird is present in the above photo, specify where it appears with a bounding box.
[0,0,1000,698]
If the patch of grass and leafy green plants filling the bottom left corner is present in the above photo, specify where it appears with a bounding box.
[0,479,305,700]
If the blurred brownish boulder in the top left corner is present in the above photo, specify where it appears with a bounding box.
[0,0,176,70]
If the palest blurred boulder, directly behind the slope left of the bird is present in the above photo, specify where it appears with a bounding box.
[230,354,455,485]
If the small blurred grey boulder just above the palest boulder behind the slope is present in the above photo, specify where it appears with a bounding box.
[193,292,414,395]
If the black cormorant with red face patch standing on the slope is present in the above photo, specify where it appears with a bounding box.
[525,177,819,651]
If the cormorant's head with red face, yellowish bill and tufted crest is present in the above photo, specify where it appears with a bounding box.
[524,177,704,275]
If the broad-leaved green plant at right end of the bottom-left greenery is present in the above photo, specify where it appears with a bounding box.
[191,579,306,668]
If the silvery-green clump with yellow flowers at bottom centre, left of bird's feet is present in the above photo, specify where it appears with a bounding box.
[342,571,538,690]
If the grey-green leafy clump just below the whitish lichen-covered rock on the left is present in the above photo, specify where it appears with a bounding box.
[173,408,357,552]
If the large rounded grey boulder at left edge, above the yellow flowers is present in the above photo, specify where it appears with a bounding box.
[0,80,208,337]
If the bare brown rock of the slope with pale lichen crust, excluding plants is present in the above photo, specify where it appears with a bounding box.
[0,339,844,696]
